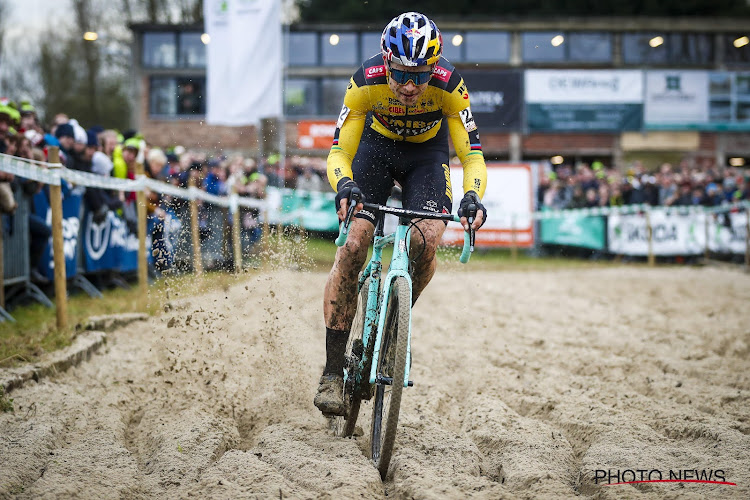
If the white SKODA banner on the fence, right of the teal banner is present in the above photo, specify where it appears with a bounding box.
[607,210,706,256]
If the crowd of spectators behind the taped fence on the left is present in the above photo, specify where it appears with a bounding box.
[0,100,330,281]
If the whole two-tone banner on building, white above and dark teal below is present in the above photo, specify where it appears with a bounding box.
[524,70,643,132]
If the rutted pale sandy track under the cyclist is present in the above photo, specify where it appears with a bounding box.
[0,266,750,499]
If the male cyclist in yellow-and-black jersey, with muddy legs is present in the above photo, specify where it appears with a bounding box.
[315,12,487,415]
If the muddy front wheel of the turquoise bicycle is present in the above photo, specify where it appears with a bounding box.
[370,276,411,480]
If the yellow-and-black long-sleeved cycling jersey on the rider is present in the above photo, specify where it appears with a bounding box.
[328,54,487,197]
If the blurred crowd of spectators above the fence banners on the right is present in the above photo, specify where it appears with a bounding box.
[537,158,750,210]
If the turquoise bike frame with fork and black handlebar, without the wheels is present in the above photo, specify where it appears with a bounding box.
[336,200,474,391]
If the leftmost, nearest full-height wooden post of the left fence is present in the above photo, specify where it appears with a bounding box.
[49,146,68,330]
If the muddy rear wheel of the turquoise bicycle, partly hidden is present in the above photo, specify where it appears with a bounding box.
[332,278,374,437]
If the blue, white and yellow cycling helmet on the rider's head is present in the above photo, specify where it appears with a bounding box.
[380,12,443,66]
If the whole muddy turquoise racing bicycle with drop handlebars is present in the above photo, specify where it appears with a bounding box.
[331,189,477,479]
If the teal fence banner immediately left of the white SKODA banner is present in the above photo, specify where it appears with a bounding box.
[539,214,607,250]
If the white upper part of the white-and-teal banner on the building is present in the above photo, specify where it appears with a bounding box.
[524,70,643,104]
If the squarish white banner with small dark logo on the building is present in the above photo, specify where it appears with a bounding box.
[644,71,708,125]
